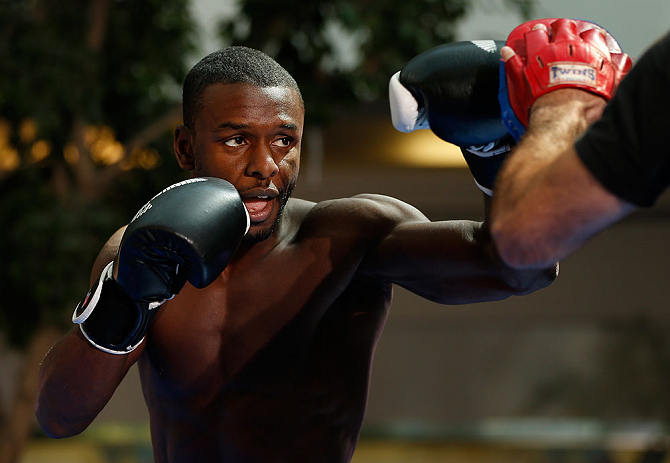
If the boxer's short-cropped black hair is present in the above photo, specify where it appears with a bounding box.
[182,46,304,129]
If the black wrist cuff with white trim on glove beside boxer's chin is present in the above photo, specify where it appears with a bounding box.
[72,262,160,355]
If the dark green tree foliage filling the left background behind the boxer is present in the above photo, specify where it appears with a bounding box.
[0,0,195,346]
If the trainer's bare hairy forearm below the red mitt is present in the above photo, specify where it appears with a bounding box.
[491,89,605,267]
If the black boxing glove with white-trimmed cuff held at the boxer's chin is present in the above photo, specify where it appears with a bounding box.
[72,177,249,354]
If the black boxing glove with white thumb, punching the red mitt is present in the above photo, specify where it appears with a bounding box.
[389,40,513,194]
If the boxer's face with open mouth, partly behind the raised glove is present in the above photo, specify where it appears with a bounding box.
[180,83,304,241]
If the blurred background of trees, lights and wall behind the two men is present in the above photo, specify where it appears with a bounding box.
[0,0,670,463]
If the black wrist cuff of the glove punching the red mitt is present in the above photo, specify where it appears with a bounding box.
[461,135,514,196]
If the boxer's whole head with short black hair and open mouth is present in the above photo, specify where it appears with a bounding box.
[175,47,305,241]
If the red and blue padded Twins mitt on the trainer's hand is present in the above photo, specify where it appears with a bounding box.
[498,18,632,140]
